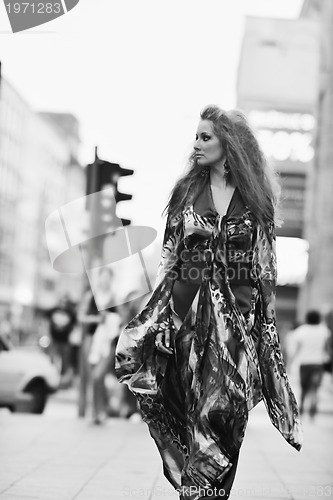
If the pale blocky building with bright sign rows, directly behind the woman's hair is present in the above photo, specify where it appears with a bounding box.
[237,17,320,331]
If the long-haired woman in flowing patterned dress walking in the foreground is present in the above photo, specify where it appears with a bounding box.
[116,106,301,500]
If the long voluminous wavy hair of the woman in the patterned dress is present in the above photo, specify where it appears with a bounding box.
[162,105,281,228]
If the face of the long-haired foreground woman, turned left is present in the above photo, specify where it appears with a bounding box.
[193,120,224,167]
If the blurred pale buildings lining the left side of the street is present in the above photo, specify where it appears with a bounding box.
[0,70,85,342]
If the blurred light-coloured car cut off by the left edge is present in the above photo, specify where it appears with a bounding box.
[0,337,60,414]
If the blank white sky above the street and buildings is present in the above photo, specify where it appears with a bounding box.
[0,0,303,235]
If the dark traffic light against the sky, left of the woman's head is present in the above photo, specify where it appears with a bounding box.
[86,150,133,232]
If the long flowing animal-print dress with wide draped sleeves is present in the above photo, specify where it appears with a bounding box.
[116,182,302,500]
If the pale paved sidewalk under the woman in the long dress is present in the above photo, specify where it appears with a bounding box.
[0,378,333,500]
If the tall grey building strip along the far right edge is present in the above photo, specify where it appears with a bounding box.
[301,0,333,314]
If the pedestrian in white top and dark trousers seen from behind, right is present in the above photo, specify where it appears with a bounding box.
[290,310,331,417]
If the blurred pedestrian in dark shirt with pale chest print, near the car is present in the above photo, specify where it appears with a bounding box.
[48,294,76,385]
